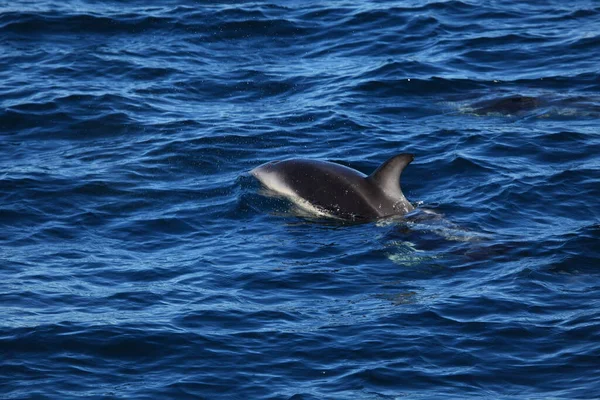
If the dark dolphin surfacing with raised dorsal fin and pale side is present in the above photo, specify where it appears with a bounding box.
[250,154,414,220]
